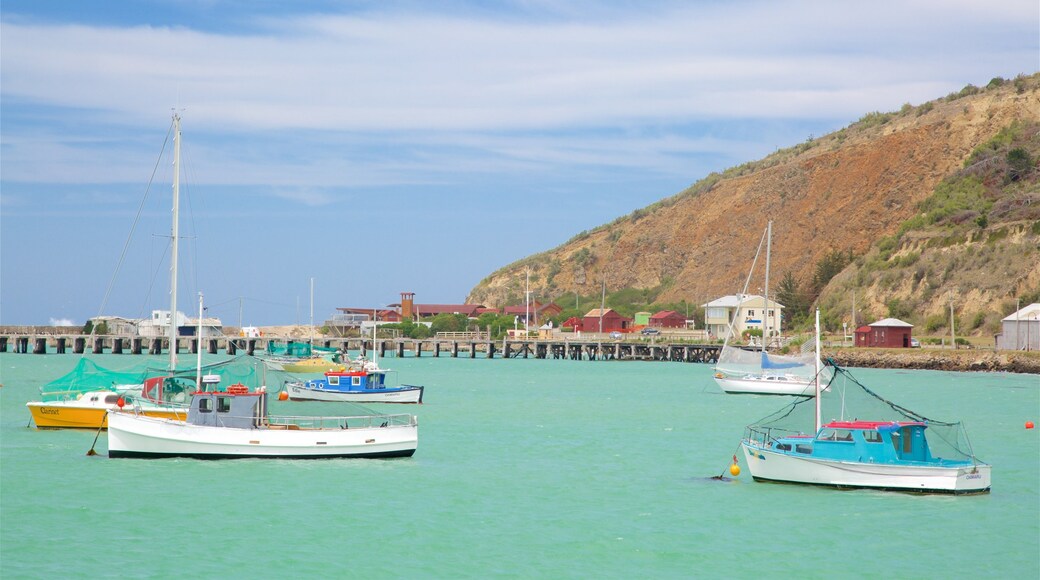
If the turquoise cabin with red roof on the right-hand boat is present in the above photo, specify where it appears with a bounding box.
[772,421,935,464]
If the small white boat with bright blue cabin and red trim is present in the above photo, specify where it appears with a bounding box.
[285,359,424,403]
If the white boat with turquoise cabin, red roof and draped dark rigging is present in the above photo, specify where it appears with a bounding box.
[740,311,991,494]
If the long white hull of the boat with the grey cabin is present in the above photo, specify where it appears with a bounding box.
[108,413,418,459]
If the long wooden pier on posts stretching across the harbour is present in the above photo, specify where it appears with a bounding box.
[0,334,722,364]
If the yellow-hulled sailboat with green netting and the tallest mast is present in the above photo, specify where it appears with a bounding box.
[25,113,201,429]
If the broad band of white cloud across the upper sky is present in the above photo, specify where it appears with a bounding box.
[2,2,1037,131]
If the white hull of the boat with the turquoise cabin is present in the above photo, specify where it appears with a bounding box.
[740,440,990,494]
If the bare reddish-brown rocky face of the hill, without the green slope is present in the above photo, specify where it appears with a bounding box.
[468,75,1040,330]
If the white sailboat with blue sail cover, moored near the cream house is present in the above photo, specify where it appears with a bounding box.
[714,221,830,397]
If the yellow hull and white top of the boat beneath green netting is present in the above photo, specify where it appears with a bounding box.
[25,391,187,429]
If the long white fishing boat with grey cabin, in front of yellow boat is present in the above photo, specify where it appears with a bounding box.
[108,380,419,459]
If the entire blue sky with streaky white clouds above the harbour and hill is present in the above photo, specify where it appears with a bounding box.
[0,0,1040,325]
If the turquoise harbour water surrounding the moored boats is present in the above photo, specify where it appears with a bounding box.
[0,353,1040,579]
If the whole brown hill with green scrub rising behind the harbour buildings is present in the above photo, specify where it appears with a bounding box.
[467,74,1040,335]
